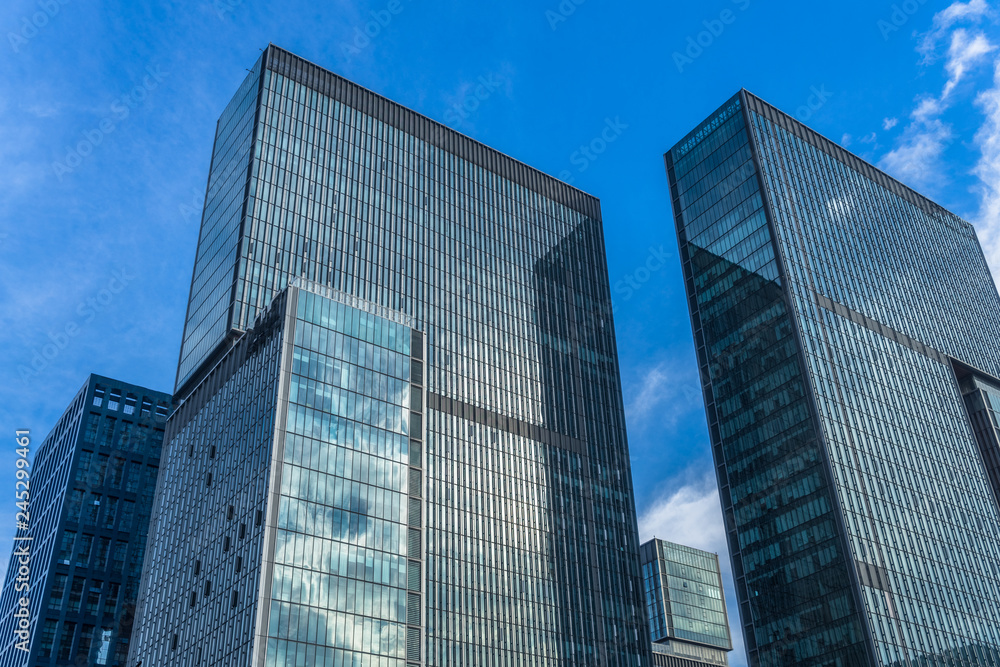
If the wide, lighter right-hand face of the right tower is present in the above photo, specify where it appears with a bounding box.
[751,100,1000,667]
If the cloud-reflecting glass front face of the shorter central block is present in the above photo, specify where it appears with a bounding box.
[265,291,422,667]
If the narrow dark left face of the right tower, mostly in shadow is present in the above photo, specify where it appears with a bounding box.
[667,97,866,667]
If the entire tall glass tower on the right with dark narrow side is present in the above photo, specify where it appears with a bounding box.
[666,91,1000,667]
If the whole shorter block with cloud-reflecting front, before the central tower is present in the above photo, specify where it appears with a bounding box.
[130,279,427,667]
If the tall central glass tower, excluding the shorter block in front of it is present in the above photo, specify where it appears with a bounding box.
[135,46,649,666]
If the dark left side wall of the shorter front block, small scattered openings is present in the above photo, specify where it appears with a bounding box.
[130,310,284,667]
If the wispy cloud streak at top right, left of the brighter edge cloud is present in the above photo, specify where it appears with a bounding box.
[879,0,996,193]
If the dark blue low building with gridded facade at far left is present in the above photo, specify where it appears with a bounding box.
[0,375,171,667]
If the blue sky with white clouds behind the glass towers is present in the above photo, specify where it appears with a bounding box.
[0,0,1000,665]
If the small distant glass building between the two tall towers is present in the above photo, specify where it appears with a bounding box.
[639,539,733,667]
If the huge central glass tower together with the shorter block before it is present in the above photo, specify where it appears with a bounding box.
[131,46,650,667]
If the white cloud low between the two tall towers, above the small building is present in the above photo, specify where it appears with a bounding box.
[639,474,747,667]
